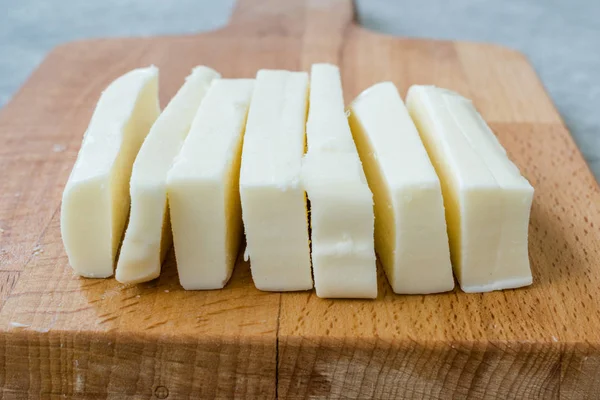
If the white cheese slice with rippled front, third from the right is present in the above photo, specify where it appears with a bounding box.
[302,64,377,298]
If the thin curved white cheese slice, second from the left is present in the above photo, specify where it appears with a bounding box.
[115,66,220,283]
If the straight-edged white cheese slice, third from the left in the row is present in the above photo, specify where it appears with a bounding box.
[167,79,254,290]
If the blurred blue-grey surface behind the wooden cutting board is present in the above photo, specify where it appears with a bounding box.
[0,0,600,178]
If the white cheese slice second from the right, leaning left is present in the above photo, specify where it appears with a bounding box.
[349,82,454,294]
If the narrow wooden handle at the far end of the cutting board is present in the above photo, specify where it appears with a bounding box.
[229,0,354,36]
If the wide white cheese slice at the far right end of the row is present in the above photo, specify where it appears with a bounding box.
[407,86,533,292]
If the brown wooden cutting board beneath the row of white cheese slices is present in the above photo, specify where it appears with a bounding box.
[0,0,600,399]
